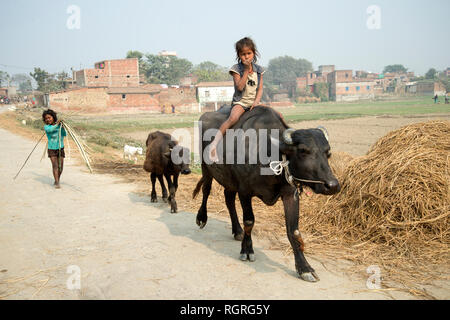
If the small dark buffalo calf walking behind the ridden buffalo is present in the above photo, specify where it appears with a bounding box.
[144,131,191,213]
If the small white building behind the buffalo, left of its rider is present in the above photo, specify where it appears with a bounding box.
[196,81,234,112]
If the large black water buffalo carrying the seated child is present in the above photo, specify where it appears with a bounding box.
[193,106,340,282]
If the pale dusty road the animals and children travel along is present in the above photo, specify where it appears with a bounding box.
[0,122,418,299]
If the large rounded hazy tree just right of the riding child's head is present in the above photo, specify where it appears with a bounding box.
[264,56,313,85]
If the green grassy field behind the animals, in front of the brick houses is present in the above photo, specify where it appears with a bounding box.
[14,96,450,149]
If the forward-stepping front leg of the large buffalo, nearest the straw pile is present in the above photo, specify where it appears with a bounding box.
[281,186,319,282]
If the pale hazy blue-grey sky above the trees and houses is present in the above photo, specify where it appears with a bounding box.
[0,0,450,74]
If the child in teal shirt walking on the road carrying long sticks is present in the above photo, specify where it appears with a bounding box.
[42,109,67,189]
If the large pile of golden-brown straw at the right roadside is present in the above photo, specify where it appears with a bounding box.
[305,121,450,298]
